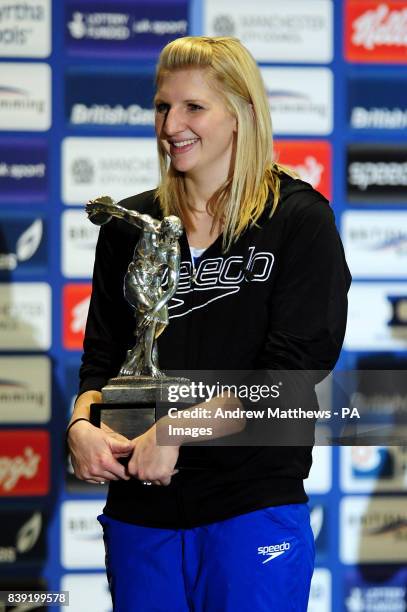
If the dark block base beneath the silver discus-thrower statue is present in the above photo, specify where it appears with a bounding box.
[90,376,190,440]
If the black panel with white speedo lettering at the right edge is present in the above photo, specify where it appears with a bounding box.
[347,143,407,204]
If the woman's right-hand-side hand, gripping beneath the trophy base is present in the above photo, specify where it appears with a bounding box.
[127,425,179,486]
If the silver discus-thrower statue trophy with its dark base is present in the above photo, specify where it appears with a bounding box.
[86,196,189,438]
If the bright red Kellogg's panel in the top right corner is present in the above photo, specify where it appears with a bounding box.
[345,0,407,63]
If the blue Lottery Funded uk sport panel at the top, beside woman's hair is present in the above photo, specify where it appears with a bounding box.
[65,0,188,58]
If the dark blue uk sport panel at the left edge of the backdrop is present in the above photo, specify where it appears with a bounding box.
[0,138,48,204]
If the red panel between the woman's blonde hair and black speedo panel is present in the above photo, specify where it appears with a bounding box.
[274,140,332,200]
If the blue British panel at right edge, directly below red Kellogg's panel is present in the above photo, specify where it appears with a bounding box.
[348,74,407,131]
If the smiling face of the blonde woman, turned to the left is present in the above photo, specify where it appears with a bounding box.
[155,68,236,182]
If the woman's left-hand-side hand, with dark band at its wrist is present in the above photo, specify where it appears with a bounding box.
[68,421,133,483]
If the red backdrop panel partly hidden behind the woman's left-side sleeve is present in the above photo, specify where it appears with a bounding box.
[63,283,92,350]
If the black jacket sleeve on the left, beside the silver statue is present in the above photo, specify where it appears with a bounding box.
[79,220,135,394]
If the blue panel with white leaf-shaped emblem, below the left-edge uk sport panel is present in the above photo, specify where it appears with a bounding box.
[0,210,48,280]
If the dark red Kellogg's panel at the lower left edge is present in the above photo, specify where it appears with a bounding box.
[0,430,49,496]
